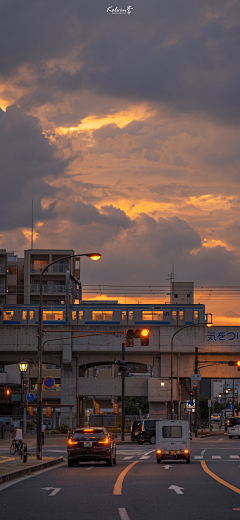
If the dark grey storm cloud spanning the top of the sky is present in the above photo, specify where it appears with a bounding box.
[0,0,240,122]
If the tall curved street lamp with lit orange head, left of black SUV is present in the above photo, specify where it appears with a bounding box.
[37,253,101,460]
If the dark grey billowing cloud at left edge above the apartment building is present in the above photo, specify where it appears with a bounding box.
[0,107,67,231]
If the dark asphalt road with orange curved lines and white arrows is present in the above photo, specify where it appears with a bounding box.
[0,436,240,520]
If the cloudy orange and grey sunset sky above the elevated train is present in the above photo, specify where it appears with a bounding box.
[0,0,240,324]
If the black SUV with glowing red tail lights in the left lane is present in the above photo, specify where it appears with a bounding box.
[67,427,116,467]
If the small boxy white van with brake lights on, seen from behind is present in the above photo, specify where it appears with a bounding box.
[156,420,191,464]
